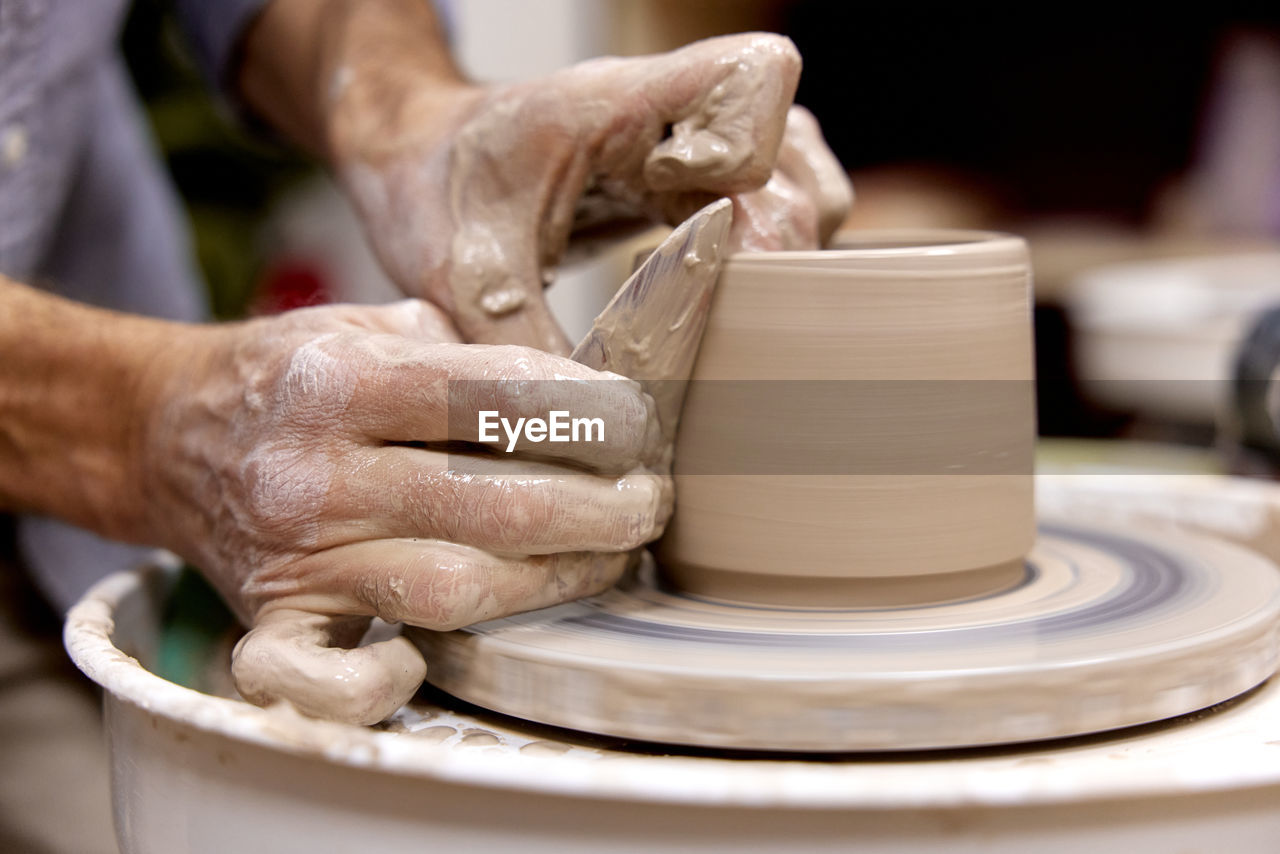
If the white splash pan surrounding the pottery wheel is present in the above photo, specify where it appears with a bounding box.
[67,475,1280,854]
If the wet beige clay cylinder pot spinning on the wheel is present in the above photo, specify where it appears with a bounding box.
[658,230,1036,607]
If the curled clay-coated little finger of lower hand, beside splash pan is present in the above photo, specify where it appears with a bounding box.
[232,608,426,725]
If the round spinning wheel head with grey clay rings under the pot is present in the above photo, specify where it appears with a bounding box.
[412,524,1280,752]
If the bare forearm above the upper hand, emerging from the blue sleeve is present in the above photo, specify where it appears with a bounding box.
[236,0,475,160]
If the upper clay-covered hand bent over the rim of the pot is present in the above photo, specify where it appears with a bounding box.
[326,33,852,352]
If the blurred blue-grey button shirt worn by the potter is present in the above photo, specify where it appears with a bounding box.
[0,0,266,608]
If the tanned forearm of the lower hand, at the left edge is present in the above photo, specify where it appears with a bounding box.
[0,277,180,540]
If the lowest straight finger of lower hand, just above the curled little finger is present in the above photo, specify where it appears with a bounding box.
[268,539,632,631]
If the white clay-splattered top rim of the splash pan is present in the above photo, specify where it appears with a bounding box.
[64,475,1280,809]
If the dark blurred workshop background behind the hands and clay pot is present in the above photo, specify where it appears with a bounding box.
[124,0,1280,472]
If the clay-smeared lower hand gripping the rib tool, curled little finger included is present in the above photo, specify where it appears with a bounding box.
[137,300,671,723]
